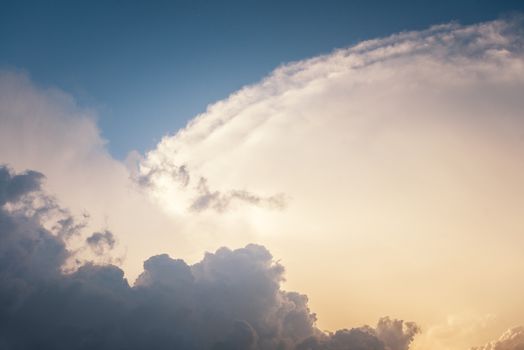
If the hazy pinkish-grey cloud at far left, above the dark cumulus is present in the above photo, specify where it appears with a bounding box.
[0,70,186,277]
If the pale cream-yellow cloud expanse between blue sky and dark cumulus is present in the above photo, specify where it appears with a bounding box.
[0,19,524,350]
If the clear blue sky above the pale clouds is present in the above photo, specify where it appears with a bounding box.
[0,0,524,158]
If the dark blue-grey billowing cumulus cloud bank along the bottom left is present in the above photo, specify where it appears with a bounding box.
[0,168,418,350]
